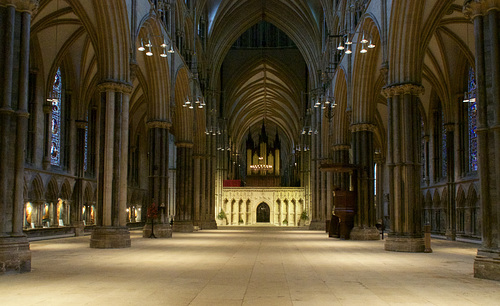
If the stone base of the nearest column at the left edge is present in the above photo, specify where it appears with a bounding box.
[0,236,31,275]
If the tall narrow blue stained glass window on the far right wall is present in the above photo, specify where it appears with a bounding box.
[467,67,477,171]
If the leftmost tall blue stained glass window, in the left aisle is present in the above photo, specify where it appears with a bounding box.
[50,68,62,166]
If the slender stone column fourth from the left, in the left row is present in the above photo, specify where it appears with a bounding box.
[172,142,194,232]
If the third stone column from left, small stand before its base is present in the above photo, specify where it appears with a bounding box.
[143,120,172,238]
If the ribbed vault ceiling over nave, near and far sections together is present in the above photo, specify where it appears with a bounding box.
[206,0,322,153]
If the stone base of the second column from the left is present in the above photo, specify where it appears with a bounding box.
[90,226,130,249]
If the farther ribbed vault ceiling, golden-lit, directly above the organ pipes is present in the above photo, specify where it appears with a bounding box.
[225,58,301,152]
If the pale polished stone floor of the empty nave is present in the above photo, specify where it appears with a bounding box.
[0,228,500,306]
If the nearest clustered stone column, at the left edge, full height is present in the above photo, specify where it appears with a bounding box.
[0,0,37,275]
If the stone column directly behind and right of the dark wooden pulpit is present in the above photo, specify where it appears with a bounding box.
[350,123,380,240]
